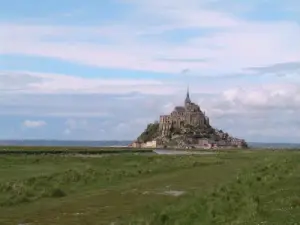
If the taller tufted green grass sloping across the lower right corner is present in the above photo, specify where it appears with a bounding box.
[119,157,300,225]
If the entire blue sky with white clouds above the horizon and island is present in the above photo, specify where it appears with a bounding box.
[0,0,300,143]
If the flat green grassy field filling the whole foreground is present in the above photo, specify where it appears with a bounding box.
[0,151,300,225]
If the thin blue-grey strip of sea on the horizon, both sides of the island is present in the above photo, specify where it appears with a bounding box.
[0,140,300,149]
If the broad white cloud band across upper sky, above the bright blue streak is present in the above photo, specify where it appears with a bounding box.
[0,0,300,75]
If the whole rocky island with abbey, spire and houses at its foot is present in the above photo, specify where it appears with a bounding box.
[130,90,248,149]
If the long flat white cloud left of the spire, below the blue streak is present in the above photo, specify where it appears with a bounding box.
[0,71,180,94]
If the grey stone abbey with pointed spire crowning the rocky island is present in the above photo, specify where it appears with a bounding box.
[159,89,209,135]
